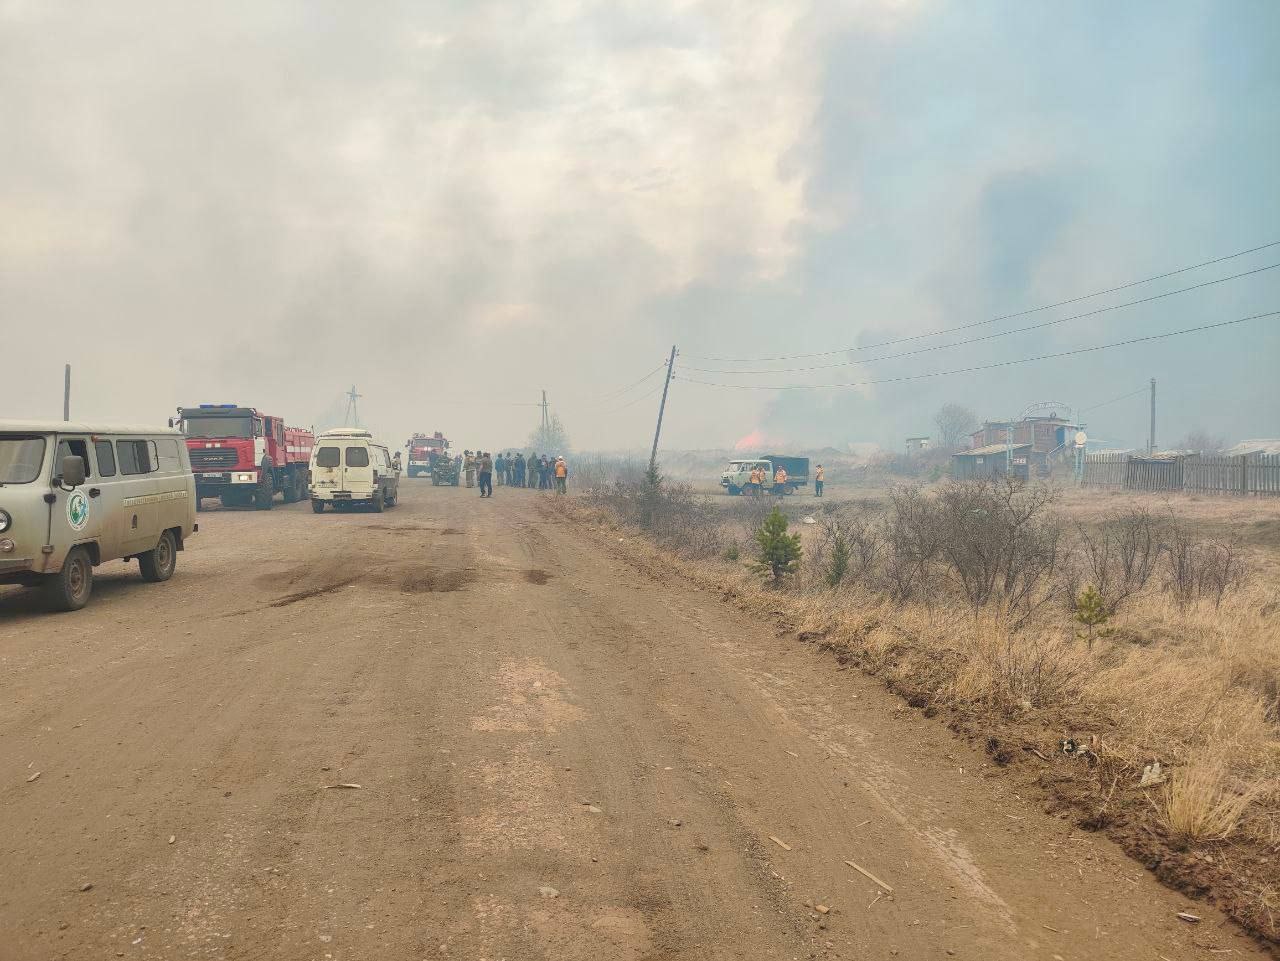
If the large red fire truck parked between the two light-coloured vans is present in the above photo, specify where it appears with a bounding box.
[178,404,315,511]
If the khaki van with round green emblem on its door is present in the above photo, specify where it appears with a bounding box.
[0,421,197,610]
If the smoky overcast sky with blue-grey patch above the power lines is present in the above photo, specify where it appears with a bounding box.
[0,0,1280,449]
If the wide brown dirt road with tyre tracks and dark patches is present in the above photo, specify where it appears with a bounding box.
[0,481,1261,961]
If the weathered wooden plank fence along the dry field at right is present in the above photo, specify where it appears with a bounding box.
[1082,454,1280,495]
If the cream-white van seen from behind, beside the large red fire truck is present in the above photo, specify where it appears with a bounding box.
[311,427,399,514]
